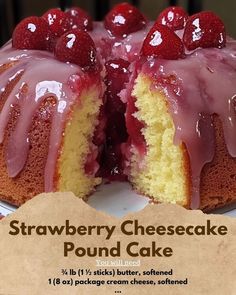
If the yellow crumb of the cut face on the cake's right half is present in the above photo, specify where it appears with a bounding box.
[126,74,189,206]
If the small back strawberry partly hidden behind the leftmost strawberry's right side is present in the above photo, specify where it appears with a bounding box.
[42,8,70,37]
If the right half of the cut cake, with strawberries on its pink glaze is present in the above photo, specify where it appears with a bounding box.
[124,12,236,211]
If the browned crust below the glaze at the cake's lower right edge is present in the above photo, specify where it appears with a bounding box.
[200,115,236,211]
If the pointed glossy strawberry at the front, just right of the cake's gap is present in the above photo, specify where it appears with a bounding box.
[141,23,184,59]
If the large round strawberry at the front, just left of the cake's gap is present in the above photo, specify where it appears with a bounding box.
[55,29,96,69]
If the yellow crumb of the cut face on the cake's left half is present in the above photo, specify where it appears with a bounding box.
[57,86,102,197]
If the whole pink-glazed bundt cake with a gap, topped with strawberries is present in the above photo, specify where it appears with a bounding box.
[0,3,236,211]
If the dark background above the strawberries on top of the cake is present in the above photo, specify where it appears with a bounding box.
[0,0,236,45]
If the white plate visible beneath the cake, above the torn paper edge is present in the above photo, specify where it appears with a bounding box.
[0,182,236,217]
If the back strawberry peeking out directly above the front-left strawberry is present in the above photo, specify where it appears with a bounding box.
[66,7,93,31]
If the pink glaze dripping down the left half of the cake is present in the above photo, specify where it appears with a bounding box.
[0,44,98,192]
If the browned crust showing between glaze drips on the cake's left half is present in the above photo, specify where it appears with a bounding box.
[0,66,55,206]
